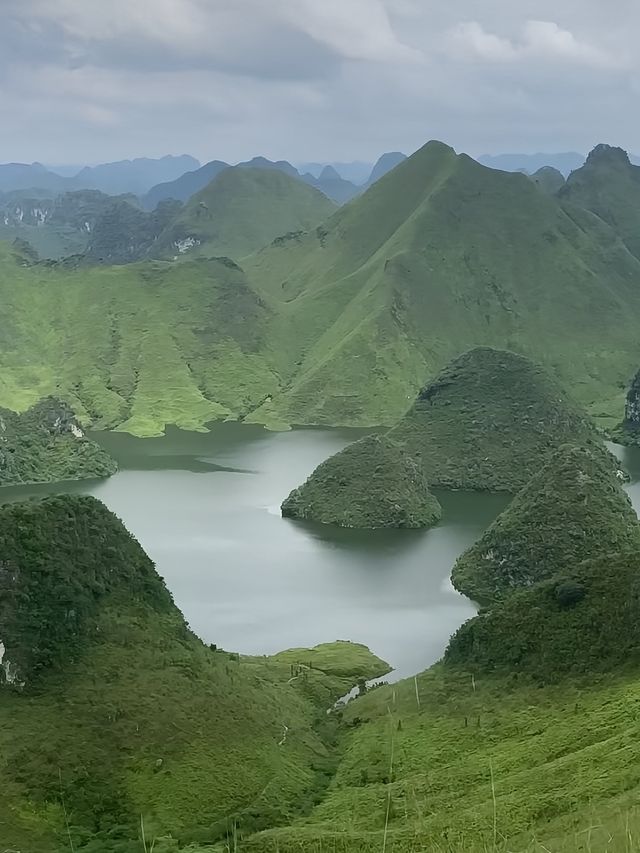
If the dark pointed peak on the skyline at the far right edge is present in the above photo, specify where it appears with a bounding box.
[560,144,640,258]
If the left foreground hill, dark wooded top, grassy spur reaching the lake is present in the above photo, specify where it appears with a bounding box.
[0,496,388,853]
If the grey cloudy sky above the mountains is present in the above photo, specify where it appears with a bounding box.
[0,0,640,163]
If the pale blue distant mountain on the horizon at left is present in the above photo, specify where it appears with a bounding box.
[71,154,200,195]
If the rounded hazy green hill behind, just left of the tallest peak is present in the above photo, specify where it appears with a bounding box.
[154,166,335,260]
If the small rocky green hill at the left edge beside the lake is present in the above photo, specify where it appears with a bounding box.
[0,397,117,482]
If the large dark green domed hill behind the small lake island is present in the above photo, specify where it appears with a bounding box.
[389,347,613,492]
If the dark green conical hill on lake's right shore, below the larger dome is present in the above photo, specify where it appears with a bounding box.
[452,446,640,604]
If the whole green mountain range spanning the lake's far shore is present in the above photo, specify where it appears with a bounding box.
[0,142,640,434]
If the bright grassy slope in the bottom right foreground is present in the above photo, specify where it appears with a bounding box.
[238,666,640,853]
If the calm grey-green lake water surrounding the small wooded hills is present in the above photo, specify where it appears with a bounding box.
[7,423,640,678]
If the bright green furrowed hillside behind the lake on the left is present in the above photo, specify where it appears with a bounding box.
[0,243,279,435]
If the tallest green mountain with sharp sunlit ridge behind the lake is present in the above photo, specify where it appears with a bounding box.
[243,142,640,425]
